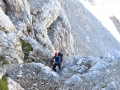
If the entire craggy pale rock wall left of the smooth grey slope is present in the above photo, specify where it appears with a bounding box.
[0,0,74,63]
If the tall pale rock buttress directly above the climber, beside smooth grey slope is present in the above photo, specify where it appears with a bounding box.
[28,0,74,55]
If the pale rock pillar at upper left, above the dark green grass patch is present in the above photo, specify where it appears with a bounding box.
[4,0,32,36]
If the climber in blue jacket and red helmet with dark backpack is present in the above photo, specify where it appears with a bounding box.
[52,52,61,72]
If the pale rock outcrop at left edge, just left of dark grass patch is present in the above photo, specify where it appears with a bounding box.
[0,31,24,63]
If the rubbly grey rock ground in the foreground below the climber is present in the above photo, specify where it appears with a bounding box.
[0,51,120,90]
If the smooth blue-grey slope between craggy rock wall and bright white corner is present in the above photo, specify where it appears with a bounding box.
[59,0,120,56]
